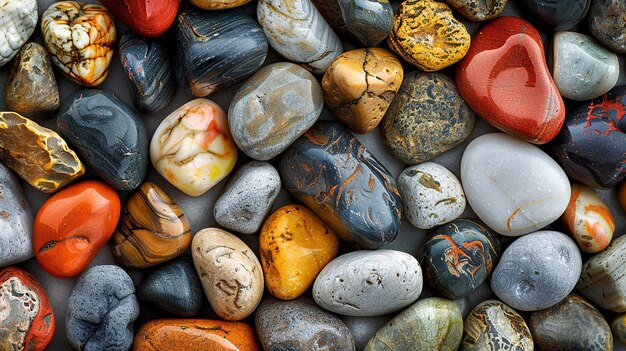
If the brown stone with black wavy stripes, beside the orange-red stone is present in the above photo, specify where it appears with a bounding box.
[113,182,191,268]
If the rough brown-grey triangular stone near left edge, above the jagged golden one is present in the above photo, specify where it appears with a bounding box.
[4,43,61,117]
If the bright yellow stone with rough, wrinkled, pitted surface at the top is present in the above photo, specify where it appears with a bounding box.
[387,0,471,72]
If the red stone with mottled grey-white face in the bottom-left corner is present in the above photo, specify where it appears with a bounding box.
[0,266,56,351]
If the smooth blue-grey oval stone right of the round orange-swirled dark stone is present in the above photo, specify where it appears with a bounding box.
[491,230,582,311]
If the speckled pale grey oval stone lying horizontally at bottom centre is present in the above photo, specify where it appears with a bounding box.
[313,249,423,316]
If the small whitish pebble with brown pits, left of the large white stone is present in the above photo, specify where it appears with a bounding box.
[398,162,466,229]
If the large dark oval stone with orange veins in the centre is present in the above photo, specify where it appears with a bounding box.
[280,121,402,248]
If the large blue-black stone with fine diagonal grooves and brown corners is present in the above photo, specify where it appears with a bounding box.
[174,8,267,97]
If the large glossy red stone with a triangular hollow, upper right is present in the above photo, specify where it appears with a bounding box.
[456,17,565,144]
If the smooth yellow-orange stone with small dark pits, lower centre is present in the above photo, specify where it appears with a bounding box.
[259,205,339,300]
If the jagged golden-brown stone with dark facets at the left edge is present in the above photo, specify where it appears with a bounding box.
[0,112,85,193]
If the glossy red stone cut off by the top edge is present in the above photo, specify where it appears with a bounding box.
[100,0,180,38]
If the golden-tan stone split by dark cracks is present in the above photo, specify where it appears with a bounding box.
[322,48,404,134]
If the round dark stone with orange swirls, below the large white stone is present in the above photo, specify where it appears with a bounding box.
[419,219,501,300]
